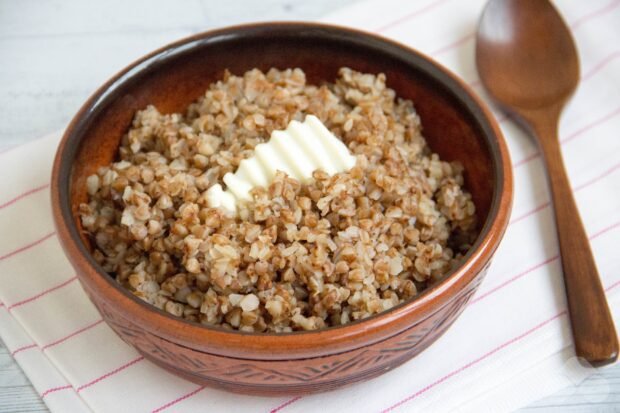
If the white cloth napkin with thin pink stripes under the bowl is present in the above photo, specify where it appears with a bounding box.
[0,0,620,412]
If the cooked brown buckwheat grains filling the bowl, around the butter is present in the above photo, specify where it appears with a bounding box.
[80,68,477,332]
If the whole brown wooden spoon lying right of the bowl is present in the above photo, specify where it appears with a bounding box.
[476,0,618,366]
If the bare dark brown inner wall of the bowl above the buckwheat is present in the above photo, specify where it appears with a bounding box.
[69,24,494,235]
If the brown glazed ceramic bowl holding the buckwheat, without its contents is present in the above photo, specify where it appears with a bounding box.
[52,23,512,395]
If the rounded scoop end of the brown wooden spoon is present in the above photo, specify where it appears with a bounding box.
[476,0,579,109]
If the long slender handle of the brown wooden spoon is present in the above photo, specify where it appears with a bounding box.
[529,113,618,366]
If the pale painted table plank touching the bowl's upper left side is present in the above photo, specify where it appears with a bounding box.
[0,28,192,146]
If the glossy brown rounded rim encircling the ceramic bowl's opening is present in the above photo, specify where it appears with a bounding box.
[51,21,513,359]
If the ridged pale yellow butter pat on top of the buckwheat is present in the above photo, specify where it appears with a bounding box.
[206,115,355,214]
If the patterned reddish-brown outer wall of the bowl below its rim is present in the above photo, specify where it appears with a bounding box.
[89,266,488,396]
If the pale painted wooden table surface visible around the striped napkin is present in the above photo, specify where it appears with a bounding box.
[0,0,620,413]
